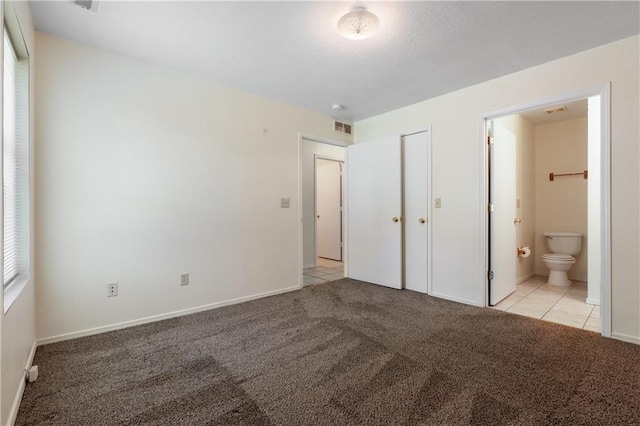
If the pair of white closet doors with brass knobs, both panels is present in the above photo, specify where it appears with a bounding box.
[347,132,429,293]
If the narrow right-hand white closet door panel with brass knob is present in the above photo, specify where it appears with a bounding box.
[403,132,429,293]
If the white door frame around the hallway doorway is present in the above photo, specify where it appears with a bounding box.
[298,132,350,288]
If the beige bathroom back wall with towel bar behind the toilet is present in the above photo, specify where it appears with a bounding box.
[534,116,587,281]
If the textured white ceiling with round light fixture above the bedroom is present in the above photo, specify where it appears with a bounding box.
[31,0,640,120]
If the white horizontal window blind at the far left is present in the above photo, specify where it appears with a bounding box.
[2,28,29,287]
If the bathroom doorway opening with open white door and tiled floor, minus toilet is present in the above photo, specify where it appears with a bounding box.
[483,86,610,335]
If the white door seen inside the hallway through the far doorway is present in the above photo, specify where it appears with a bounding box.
[316,158,342,261]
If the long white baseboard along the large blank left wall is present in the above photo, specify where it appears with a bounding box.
[37,286,301,346]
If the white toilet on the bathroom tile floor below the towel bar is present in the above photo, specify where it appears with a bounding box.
[542,232,582,287]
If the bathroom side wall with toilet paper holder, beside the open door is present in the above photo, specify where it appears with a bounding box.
[495,114,536,283]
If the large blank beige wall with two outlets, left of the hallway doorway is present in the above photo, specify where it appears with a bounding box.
[36,33,350,342]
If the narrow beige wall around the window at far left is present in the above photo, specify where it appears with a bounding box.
[0,2,36,425]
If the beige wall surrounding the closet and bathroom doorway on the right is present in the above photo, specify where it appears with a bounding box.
[355,36,640,343]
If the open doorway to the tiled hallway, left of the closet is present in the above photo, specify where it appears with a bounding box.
[298,135,347,287]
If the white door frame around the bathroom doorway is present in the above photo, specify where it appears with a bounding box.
[478,82,611,337]
